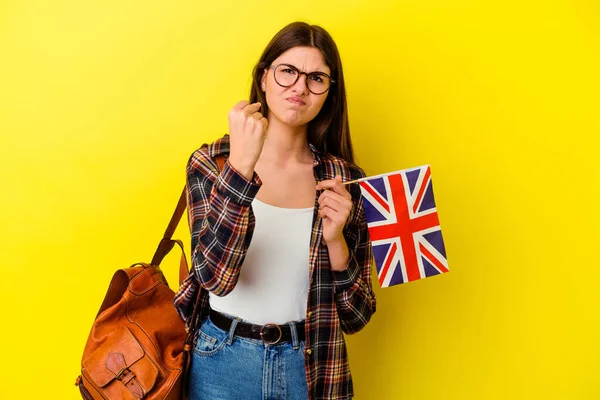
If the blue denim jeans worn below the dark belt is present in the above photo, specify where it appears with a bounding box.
[188,317,308,400]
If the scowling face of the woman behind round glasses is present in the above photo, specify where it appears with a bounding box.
[261,47,331,127]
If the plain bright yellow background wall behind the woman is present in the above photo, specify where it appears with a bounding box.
[0,0,600,400]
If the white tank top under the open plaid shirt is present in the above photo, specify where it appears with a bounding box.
[209,198,314,325]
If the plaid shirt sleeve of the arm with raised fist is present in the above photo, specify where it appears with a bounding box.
[186,149,262,296]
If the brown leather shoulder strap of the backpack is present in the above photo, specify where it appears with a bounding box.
[150,154,226,285]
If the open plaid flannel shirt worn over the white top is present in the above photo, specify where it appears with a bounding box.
[174,135,376,400]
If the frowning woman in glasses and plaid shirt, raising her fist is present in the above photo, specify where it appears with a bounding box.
[175,22,376,400]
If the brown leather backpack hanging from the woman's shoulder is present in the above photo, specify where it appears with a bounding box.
[75,157,224,400]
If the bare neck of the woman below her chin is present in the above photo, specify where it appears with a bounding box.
[260,118,312,165]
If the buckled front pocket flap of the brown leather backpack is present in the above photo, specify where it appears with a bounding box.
[82,327,158,399]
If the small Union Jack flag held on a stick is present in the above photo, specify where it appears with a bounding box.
[359,165,448,287]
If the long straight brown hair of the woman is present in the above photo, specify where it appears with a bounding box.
[250,22,354,163]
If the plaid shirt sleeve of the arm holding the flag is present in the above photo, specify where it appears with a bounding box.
[332,167,376,334]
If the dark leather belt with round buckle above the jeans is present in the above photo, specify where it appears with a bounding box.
[210,308,304,344]
